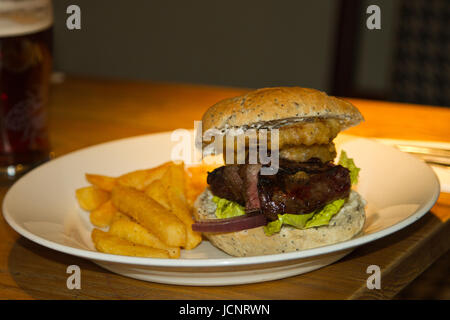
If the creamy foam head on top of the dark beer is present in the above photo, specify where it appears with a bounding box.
[0,0,53,37]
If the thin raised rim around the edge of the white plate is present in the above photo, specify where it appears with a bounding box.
[2,131,440,268]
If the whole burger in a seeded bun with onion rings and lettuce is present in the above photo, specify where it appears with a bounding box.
[192,87,365,256]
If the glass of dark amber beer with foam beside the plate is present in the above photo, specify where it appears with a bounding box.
[0,0,53,181]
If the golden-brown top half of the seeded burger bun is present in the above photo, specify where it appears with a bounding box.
[202,87,364,133]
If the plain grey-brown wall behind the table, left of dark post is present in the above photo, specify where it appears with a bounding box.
[54,0,338,90]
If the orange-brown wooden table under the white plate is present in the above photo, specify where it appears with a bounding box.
[0,77,450,299]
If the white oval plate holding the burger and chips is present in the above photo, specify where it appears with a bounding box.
[3,133,439,285]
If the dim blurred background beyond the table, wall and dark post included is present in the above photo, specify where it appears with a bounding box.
[54,0,450,106]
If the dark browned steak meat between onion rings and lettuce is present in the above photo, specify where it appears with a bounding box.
[207,158,351,220]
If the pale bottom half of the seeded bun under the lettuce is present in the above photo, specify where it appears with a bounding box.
[194,189,365,257]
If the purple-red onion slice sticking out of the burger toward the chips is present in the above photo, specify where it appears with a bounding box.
[192,214,267,232]
